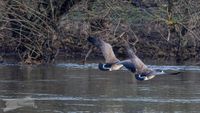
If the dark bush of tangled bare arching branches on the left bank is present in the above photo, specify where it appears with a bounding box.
[0,0,82,64]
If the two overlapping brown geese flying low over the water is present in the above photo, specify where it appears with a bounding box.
[87,36,180,81]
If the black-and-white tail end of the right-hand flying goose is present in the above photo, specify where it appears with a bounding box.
[135,73,155,81]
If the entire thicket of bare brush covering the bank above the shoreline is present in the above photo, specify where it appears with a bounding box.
[0,0,200,64]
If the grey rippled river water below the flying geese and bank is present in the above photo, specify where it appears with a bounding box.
[0,63,200,113]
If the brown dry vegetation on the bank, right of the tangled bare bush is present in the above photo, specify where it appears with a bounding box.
[60,0,200,62]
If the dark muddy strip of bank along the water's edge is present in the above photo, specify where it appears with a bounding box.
[0,51,200,66]
